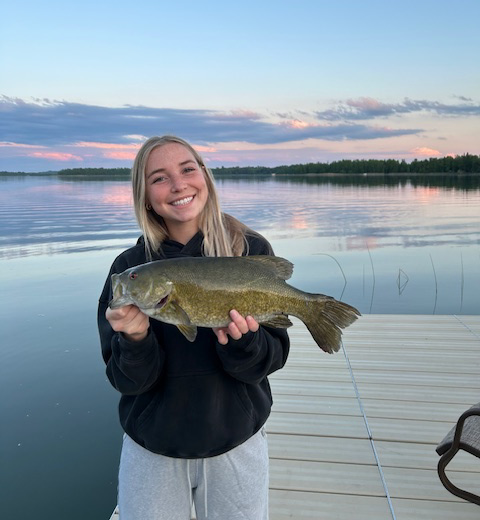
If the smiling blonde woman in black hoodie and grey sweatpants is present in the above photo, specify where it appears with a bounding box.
[98,136,289,520]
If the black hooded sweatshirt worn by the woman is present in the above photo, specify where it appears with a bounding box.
[98,232,290,458]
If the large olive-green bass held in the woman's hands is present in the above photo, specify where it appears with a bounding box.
[109,255,360,353]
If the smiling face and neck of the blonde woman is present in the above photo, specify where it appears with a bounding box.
[145,143,208,244]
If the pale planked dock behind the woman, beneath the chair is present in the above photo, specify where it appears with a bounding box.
[112,315,480,520]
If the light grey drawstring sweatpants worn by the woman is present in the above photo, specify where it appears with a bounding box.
[118,428,268,520]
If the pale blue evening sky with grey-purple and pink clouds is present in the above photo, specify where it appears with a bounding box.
[0,0,480,172]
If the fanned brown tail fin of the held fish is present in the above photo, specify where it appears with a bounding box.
[298,295,360,354]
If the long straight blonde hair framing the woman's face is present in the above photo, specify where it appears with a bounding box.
[132,135,248,260]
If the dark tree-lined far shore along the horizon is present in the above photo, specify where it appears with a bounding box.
[0,153,480,178]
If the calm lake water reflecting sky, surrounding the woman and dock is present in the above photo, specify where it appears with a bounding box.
[0,176,480,520]
